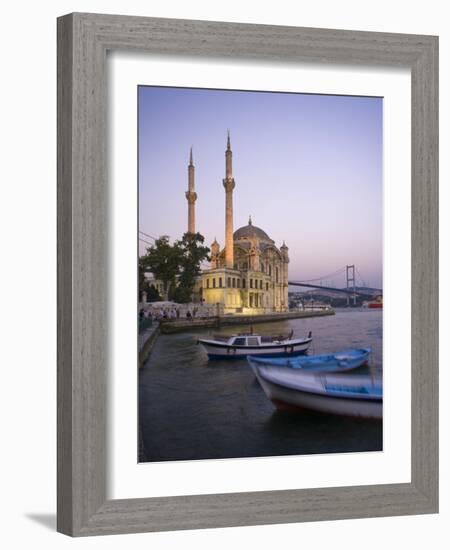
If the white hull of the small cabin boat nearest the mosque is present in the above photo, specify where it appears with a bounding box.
[199,338,312,359]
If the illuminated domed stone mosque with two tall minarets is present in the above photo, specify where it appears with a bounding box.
[186,133,289,314]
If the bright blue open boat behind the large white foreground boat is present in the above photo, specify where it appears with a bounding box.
[248,348,371,372]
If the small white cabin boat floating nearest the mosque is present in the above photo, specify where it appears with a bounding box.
[197,332,312,359]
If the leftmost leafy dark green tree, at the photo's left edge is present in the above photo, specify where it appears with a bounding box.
[139,235,183,300]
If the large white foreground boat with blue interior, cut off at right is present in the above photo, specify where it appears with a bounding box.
[254,366,383,419]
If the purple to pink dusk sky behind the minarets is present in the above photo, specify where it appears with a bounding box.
[138,86,383,288]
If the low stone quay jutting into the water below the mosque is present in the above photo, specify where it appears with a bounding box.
[160,308,334,334]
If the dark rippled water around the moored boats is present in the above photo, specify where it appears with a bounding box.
[139,310,382,461]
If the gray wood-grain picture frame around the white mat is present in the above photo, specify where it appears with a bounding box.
[57,13,438,536]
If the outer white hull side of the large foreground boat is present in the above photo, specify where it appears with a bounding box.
[255,368,383,420]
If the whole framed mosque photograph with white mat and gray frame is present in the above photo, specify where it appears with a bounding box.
[58,14,438,536]
